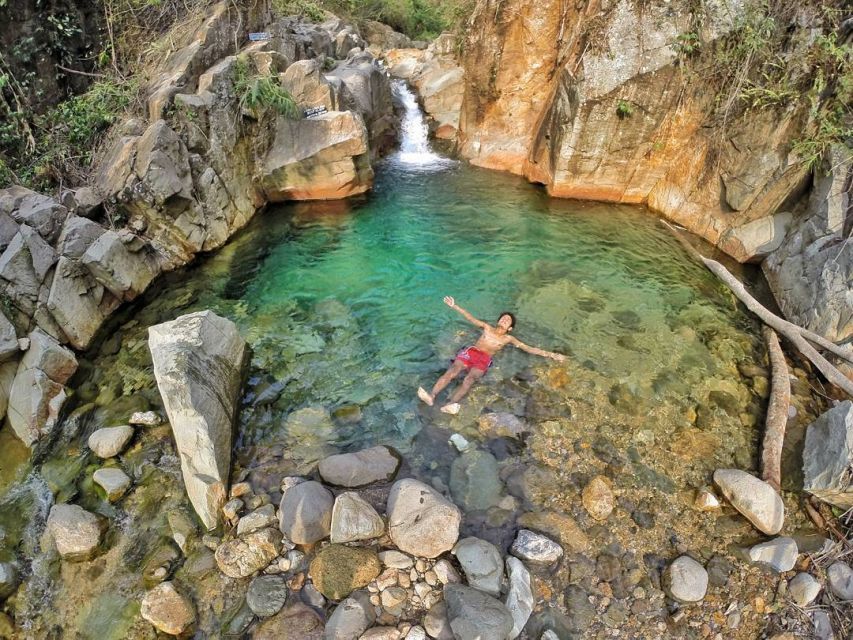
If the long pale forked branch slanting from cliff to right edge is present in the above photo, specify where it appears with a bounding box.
[662,221,853,397]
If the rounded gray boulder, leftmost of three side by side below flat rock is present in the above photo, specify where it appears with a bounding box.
[279,480,334,544]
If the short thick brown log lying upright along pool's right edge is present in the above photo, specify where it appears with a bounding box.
[761,325,791,491]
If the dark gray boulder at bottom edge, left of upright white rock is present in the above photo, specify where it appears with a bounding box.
[444,584,513,640]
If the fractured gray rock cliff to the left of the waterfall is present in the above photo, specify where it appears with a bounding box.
[0,0,408,445]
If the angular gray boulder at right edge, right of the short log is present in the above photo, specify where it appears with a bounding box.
[803,400,853,509]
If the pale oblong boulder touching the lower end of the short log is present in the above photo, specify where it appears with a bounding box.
[714,469,785,536]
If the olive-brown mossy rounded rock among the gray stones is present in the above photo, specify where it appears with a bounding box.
[308,544,382,600]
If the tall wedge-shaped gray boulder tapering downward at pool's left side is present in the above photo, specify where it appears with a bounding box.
[148,311,247,529]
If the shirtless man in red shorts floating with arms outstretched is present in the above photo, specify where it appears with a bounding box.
[418,296,566,415]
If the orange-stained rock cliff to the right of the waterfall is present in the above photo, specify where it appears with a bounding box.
[386,0,853,340]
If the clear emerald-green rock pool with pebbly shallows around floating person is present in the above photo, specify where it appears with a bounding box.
[0,117,817,639]
